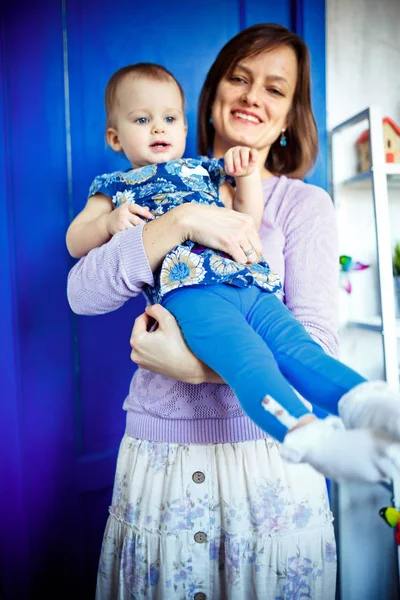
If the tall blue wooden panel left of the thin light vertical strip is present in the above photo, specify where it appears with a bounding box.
[2,0,80,598]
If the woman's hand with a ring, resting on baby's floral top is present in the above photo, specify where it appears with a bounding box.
[175,203,263,264]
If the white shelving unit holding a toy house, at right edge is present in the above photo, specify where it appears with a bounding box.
[330,107,400,600]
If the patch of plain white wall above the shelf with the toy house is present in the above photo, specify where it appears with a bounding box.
[326,0,400,129]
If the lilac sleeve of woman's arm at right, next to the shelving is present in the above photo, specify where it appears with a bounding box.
[284,185,339,356]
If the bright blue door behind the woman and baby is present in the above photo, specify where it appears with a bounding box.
[0,0,326,600]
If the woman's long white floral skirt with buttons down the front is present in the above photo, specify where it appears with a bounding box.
[96,435,336,600]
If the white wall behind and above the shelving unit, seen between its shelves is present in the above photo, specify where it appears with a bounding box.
[326,0,400,600]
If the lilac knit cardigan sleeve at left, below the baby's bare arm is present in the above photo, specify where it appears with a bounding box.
[67,224,154,315]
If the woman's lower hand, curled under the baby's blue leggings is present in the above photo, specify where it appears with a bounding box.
[130,304,224,383]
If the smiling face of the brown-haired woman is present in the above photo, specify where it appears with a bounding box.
[211,46,298,164]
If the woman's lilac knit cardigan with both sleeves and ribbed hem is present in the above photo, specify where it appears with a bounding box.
[68,176,339,444]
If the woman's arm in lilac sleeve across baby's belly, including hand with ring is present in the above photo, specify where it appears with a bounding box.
[67,204,262,315]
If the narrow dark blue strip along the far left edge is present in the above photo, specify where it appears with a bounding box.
[0,14,30,599]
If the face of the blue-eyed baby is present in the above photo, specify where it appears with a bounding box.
[113,76,187,167]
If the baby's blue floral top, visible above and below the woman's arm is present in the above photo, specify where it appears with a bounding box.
[89,157,282,303]
